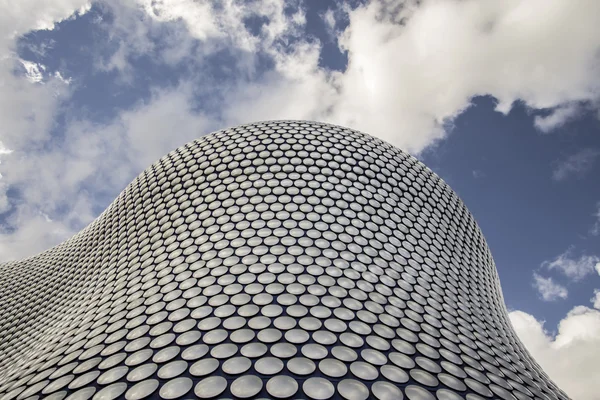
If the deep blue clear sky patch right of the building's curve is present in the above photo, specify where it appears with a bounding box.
[421,97,600,324]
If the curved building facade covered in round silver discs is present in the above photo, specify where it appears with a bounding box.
[0,121,567,400]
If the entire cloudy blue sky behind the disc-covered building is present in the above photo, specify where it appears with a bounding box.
[0,0,600,399]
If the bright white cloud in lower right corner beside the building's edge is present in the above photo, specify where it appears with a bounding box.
[509,306,600,400]
